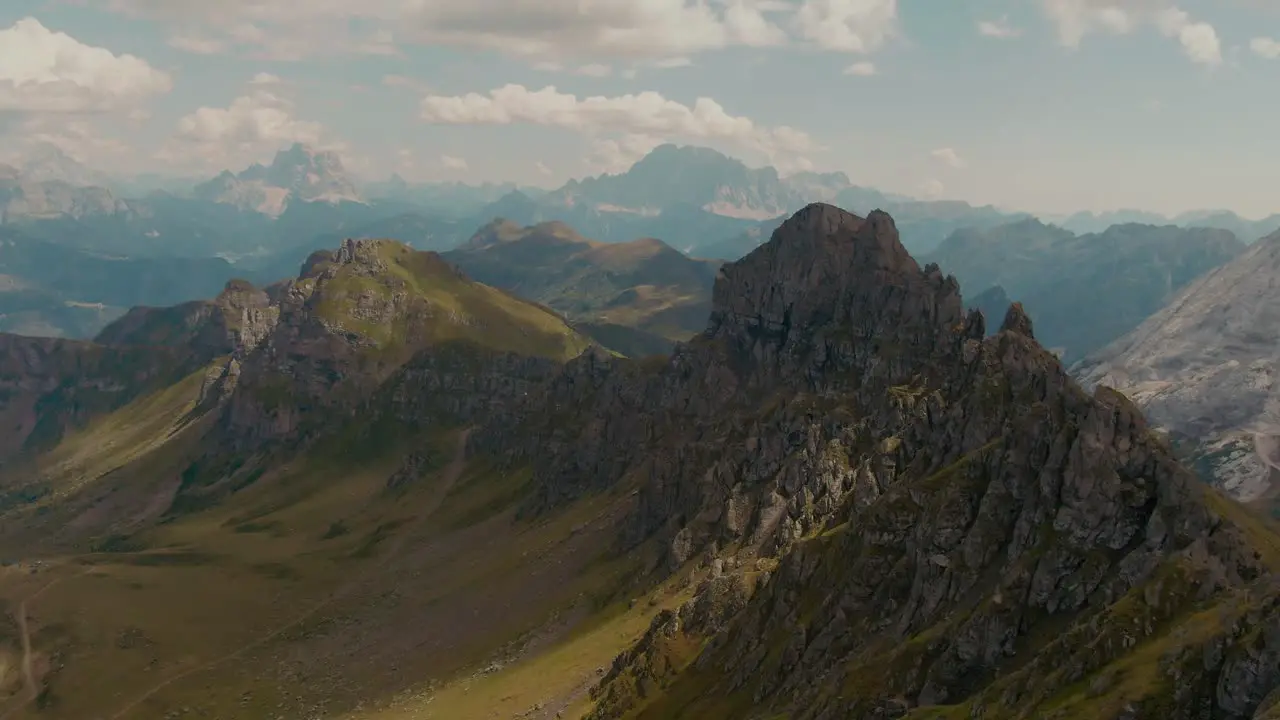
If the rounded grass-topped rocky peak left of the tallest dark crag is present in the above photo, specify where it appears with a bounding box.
[213,238,586,450]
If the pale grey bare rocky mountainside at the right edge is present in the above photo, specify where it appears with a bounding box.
[1073,229,1280,500]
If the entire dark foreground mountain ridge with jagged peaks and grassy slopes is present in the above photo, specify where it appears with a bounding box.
[0,204,1280,720]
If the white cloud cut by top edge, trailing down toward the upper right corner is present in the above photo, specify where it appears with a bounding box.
[1043,0,1222,65]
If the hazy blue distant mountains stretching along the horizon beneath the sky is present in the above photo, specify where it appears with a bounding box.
[0,143,1280,348]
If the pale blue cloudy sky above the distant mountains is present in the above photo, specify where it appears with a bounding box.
[0,0,1280,218]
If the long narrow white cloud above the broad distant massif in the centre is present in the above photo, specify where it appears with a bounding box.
[421,85,819,164]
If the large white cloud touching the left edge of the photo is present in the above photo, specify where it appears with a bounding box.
[0,18,173,113]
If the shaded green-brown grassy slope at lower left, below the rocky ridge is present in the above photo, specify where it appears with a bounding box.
[0,351,675,720]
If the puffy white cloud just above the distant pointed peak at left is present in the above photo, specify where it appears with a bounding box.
[159,90,337,168]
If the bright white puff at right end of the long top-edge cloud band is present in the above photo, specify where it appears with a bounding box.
[794,0,897,54]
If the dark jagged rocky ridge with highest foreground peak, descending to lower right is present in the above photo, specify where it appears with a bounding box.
[474,205,1280,720]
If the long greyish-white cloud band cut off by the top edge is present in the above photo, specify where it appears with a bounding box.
[88,0,897,65]
